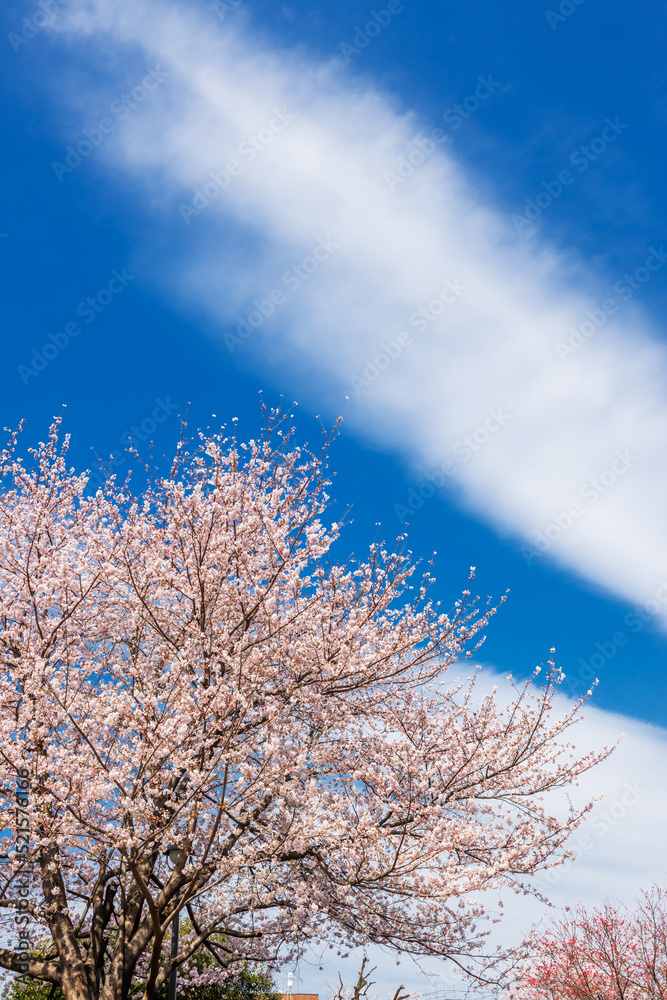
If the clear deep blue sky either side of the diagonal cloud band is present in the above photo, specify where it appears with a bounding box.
[0,0,667,724]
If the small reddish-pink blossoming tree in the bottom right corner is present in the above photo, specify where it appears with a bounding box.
[512,888,667,1000]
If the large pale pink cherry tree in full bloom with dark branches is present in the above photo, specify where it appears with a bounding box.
[0,411,608,1000]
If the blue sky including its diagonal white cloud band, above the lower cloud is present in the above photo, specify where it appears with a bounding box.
[0,0,667,984]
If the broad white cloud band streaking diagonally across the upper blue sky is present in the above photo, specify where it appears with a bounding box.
[48,0,667,620]
